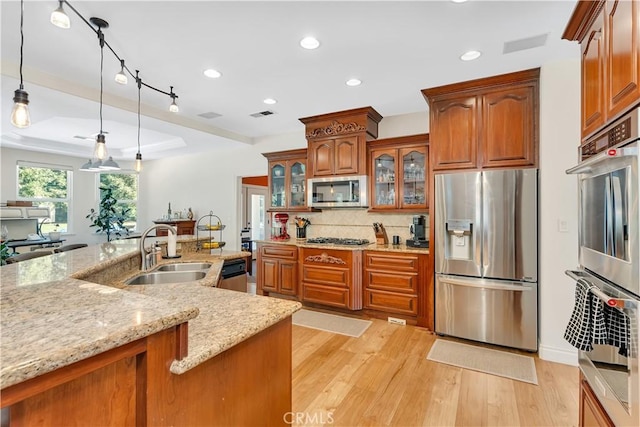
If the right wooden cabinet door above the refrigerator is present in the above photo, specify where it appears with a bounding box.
[482,86,536,167]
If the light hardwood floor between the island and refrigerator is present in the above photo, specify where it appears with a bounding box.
[286,319,578,427]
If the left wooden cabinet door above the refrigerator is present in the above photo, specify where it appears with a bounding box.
[430,97,477,170]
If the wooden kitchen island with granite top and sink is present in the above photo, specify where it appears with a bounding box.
[0,236,300,425]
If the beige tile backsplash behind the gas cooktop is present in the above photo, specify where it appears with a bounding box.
[289,209,429,242]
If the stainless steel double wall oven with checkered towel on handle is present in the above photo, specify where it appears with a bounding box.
[567,109,640,426]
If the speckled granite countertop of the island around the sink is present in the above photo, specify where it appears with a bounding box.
[0,236,301,388]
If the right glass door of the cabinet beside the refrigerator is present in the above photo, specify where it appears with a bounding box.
[399,147,428,209]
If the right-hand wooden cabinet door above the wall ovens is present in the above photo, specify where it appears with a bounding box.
[606,0,640,119]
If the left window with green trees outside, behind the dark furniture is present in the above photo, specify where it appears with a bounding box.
[17,162,73,233]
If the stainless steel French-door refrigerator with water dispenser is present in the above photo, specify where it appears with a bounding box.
[432,169,538,351]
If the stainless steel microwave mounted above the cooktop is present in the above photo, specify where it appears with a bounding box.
[307,175,369,208]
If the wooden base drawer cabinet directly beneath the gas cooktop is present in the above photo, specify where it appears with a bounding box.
[300,248,362,310]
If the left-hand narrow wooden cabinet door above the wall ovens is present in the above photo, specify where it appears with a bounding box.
[581,11,605,136]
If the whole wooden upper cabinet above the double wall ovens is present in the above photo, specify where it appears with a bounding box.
[562,0,640,139]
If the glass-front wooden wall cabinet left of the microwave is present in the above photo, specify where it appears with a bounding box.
[262,149,310,212]
